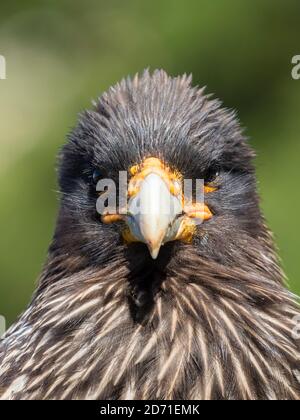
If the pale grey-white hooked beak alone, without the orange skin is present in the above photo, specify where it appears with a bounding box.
[126,173,183,259]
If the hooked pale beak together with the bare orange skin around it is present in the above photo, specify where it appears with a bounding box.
[102,157,216,259]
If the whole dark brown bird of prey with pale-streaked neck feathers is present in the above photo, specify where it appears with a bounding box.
[0,70,300,400]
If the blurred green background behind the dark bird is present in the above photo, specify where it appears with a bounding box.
[0,0,300,323]
